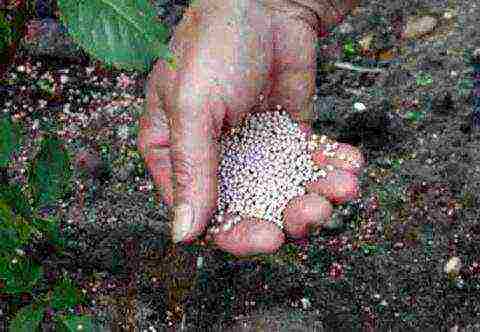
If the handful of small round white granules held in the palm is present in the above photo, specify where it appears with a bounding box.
[212,111,336,233]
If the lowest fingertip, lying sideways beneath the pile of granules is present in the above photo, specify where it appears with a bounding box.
[210,214,285,256]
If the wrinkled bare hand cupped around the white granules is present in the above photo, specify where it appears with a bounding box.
[138,0,358,255]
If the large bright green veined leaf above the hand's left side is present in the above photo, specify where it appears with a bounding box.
[58,0,174,71]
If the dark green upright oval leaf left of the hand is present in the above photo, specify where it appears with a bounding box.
[28,136,72,208]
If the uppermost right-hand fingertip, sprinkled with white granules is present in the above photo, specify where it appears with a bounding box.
[311,135,365,175]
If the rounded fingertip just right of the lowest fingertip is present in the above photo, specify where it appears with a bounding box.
[283,193,333,239]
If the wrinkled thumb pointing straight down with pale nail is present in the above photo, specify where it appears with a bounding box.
[170,95,221,243]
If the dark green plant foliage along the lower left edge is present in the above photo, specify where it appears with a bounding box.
[0,122,100,332]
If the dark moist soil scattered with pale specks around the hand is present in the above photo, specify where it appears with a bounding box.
[0,0,480,331]
